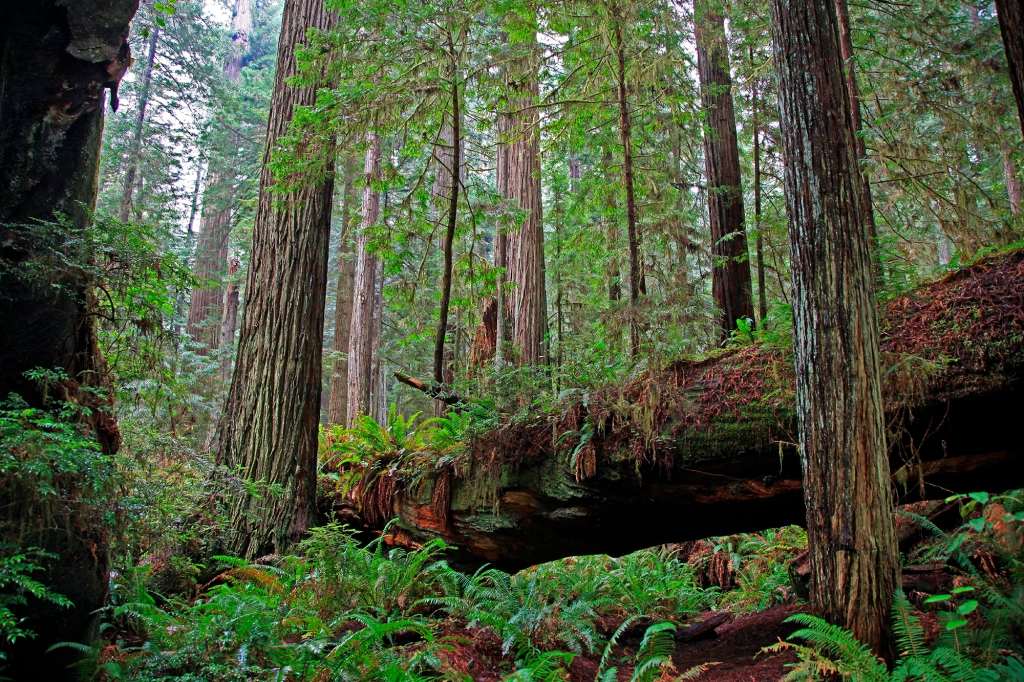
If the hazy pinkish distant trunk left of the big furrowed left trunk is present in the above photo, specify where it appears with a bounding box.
[185,0,253,355]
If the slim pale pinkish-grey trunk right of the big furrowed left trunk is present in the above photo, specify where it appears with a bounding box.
[345,132,381,428]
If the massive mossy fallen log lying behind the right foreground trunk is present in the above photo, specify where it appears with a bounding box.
[323,251,1024,569]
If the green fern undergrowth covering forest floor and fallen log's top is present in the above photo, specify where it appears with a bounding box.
[6,245,1024,680]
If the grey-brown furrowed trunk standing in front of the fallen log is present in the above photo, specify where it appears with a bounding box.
[771,0,899,656]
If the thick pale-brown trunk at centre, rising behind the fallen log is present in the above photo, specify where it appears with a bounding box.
[506,46,548,366]
